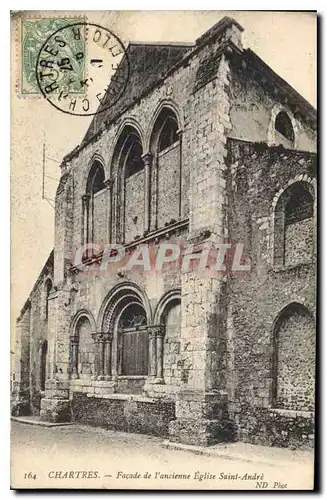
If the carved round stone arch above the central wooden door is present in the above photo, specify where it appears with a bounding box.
[97,281,152,331]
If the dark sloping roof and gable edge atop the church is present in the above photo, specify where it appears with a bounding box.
[64,17,317,161]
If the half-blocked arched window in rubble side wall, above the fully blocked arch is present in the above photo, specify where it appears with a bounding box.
[274,182,314,266]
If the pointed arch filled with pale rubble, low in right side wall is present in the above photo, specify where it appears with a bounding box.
[272,303,315,411]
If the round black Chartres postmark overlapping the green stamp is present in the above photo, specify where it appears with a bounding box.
[36,22,130,116]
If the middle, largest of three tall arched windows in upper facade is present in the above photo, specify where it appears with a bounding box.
[114,126,145,243]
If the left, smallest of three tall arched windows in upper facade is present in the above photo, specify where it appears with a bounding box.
[83,160,106,249]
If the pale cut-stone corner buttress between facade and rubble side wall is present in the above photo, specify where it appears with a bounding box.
[169,47,234,446]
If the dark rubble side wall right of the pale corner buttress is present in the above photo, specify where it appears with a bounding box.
[224,140,316,446]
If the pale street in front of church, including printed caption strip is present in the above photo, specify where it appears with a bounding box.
[11,422,313,489]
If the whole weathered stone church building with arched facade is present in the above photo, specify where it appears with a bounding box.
[12,18,317,447]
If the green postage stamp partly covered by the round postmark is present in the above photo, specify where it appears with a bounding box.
[19,17,85,95]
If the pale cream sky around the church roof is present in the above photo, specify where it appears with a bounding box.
[11,11,316,325]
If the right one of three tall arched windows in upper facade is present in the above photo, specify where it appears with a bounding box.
[150,107,183,228]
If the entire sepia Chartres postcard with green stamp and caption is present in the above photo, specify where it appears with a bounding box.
[11,11,317,491]
